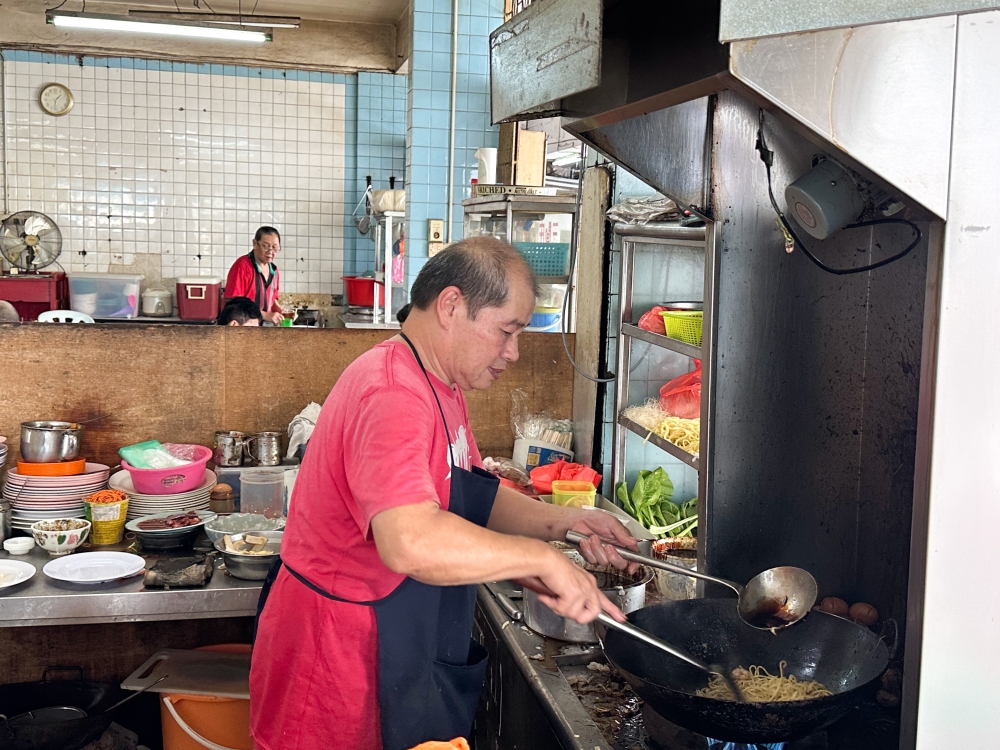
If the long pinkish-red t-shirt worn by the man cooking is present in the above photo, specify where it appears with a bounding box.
[250,341,482,750]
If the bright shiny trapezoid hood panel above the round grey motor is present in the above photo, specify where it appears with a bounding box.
[730,16,956,218]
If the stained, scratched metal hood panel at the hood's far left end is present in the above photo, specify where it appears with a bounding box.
[490,0,603,122]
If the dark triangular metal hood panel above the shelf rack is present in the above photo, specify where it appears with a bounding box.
[577,97,710,213]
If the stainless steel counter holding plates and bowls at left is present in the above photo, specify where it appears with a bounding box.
[0,547,261,627]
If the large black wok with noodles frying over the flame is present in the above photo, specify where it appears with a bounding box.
[603,599,890,743]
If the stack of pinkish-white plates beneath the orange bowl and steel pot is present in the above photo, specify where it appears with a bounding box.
[3,463,109,531]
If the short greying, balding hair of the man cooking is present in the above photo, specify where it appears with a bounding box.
[410,237,538,319]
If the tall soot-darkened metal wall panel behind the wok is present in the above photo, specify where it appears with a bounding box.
[699,92,927,636]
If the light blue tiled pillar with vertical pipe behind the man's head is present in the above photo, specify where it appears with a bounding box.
[406,0,503,286]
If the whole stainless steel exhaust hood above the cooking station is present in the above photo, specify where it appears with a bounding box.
[491,0,956,218]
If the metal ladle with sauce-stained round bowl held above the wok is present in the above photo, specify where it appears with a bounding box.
[566,531,819,631]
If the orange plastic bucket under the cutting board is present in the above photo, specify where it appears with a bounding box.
[160,643,253,750]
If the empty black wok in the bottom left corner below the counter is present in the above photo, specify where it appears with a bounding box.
[0,667,129,750]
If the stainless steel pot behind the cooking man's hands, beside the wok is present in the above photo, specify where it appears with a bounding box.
[521,558,653,643]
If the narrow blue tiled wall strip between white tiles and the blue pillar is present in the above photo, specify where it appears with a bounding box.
[344,73,407,275]
